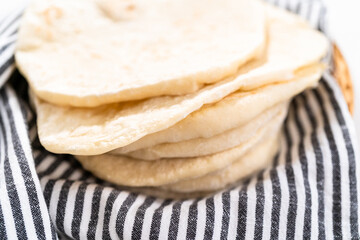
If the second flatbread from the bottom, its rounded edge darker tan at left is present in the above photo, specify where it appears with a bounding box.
[76,117,281,187]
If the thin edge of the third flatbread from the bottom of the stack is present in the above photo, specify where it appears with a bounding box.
[111,103,288,160]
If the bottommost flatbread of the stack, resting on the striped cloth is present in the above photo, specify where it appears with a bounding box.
[161,134,279,192]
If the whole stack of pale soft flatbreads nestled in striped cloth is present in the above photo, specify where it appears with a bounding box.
[16,0,328,197]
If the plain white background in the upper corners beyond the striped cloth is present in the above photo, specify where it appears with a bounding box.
[0,0,360,142]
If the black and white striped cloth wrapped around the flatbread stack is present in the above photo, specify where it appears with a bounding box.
[0,0,360,239]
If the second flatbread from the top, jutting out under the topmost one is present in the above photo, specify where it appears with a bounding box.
[32,14,327,155]
